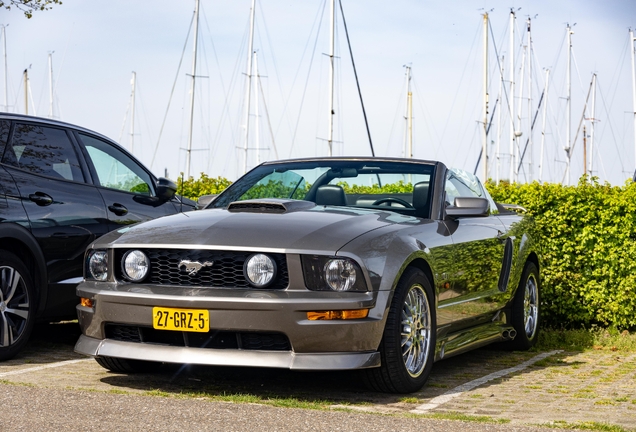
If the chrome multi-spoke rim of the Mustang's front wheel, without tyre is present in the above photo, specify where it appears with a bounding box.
[401,284,431,378]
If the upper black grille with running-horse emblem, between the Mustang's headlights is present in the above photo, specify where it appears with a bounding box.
[116,249,289,289]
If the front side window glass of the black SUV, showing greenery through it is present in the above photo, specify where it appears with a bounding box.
[79,133,154,195]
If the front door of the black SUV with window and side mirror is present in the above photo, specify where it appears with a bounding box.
[77,132,178,229]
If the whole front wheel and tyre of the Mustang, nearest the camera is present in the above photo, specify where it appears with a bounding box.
[364,268,436,393]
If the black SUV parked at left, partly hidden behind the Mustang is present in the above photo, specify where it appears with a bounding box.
[0,113,194,360]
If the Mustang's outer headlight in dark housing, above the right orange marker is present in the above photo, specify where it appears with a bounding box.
[301,255,368,292]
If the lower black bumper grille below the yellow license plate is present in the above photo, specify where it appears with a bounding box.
[105,324,291,351]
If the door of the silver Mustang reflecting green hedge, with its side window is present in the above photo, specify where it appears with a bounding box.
[439,170,506,325]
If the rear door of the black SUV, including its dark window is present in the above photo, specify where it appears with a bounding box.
[2,122,108,317]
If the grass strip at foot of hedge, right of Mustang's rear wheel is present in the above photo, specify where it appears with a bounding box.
[535,327,636,352]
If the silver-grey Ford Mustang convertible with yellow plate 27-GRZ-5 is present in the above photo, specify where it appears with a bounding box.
[75,158,540,393]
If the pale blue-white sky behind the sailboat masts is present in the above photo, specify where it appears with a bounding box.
[0,0,636,185]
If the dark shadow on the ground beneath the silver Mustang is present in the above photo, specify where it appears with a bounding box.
[95,349,573,409]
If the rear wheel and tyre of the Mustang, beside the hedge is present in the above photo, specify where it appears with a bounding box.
[510,261,540,350]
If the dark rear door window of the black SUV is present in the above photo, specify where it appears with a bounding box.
[2,123,84,182]
